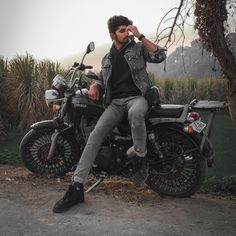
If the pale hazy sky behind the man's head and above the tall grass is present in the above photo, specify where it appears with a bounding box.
[0,0,180,60]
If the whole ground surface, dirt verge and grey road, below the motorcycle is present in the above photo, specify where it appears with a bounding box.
[0,165,236,236]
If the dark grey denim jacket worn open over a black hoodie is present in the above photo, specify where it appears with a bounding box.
[98,42,166,106]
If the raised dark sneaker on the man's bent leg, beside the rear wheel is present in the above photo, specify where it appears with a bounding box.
[130,156,149,187]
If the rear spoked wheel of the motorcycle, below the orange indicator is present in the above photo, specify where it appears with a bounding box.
[146,124,208,197]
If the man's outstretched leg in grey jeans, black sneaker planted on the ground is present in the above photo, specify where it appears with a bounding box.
[53,99,123,213]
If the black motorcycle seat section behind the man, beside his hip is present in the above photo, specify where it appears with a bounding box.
[148,104,184,118]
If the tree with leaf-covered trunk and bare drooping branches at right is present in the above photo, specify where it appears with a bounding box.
[156,0,236,126]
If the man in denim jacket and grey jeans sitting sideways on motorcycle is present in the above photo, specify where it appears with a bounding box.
[53,16,165,213]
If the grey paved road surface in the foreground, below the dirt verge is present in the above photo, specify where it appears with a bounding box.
[0,193,236,236]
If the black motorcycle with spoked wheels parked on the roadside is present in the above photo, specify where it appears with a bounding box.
[20,42,227,197]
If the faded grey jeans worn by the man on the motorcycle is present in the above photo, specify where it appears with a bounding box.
[73,96,148,183]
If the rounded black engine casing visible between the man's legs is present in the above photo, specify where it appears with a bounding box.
[94,146,116,171]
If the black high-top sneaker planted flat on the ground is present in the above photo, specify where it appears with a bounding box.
[52,183,84,213]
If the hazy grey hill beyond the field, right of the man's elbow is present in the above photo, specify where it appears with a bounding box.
[148,33,236,78]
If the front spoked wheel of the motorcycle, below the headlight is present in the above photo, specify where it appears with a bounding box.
[20,127,80,176]
